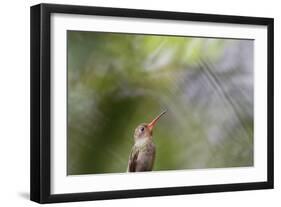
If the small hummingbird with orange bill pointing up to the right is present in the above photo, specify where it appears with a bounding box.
[127,110,167,172]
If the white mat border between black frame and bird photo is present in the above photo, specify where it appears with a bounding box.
[50,13,268,194]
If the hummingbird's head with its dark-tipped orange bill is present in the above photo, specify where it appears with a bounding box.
[134,111,167,141]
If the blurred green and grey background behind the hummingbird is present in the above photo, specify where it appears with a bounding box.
[67,31,254,175]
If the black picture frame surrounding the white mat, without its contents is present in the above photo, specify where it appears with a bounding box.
[30,4,274,203]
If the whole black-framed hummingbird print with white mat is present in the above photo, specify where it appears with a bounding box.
[31,4,273,203]
